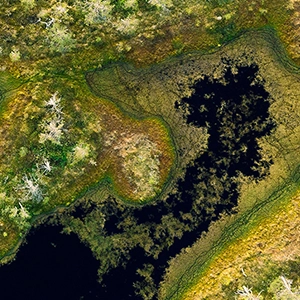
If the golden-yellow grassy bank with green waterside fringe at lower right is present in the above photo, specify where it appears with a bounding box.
[160,164,300,300]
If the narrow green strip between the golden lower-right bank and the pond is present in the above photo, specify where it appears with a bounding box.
[160,30,300,299]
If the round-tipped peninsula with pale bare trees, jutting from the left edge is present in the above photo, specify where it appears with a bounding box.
[1,74,175,255]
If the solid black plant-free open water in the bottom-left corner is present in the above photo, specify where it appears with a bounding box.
[0,226,101,300]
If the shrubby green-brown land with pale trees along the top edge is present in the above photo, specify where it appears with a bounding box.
[0,0,299,78]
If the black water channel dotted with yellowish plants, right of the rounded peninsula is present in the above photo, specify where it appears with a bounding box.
[88,60,275,299]
